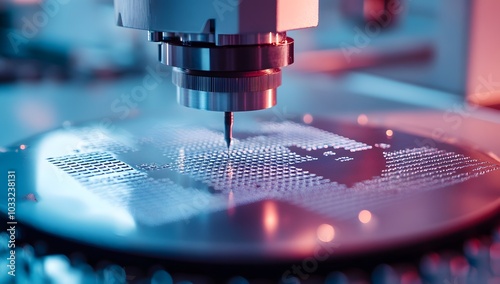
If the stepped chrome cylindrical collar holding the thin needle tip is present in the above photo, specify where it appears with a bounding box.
[159,33,294,112]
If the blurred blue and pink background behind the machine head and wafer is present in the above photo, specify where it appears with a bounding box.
[0,0,500,149]
